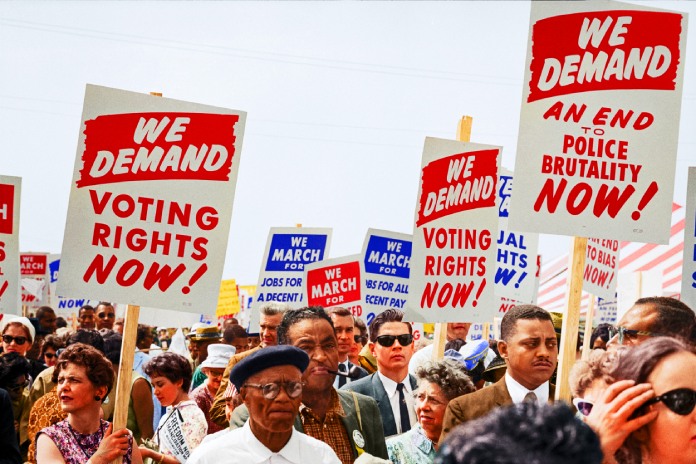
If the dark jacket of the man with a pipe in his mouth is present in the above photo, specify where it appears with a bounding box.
[230,390,389,459]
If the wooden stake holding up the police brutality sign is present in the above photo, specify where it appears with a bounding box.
[556,237,587,403]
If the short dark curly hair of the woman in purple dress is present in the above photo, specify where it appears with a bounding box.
[52,343,116,401]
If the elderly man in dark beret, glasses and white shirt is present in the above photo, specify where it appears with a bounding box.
[187,345,341,464]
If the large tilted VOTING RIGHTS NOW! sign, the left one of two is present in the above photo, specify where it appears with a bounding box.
[57,85,246,314]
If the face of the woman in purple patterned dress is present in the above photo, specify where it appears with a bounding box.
[58,363,107,413]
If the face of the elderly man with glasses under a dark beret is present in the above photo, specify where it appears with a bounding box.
[240,365,302,436]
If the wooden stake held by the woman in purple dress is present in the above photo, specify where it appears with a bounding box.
[113,305,140,464]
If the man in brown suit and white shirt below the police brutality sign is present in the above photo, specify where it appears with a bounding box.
[440,305,558,443]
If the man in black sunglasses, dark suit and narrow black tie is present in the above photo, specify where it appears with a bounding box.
[342,309,417,437]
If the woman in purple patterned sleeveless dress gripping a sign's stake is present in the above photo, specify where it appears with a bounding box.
[36,343,142,464]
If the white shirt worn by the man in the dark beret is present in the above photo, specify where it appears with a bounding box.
[186,421,341,464]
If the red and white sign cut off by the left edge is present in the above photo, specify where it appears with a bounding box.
[0,176,22,315]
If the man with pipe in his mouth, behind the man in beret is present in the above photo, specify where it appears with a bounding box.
[230,306,388,464]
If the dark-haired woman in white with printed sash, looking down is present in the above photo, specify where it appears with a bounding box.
[140,352,208,464]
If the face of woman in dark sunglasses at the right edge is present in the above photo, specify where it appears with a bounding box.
[647,352,696,464]
